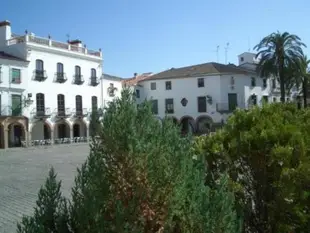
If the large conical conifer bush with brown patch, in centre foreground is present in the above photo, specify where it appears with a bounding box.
[16,90,241,233]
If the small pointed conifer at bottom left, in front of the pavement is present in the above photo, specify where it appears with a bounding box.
[17,168,69,233]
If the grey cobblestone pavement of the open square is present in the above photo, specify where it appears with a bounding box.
[0,144,89,233]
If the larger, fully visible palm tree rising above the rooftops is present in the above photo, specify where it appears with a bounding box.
[254,31,306,103]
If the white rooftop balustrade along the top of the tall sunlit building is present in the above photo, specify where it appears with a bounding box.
[7,34,102,58]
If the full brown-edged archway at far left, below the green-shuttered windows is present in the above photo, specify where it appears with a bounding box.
[7,122,26,147]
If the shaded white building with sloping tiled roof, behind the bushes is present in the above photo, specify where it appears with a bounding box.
[128,53,296,133]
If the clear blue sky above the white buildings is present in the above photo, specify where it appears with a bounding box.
[0,0,310,78]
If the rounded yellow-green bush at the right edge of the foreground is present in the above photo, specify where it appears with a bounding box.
[195,104,310,233]
